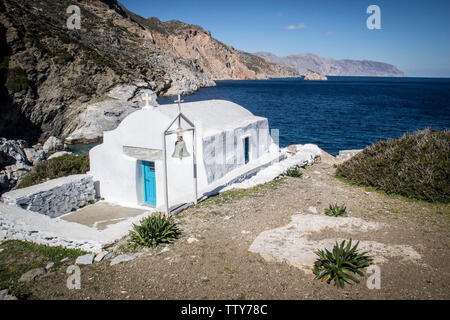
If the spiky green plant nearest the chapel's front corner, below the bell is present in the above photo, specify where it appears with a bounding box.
[129,213,181,247]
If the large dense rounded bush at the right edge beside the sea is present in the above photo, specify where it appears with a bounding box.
[336,129,450,203]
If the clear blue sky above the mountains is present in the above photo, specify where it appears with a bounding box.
[119,0,450,77]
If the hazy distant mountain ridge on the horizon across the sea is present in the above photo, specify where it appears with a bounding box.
[254,52,404,77]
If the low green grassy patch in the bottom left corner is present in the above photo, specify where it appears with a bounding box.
[0,240,86,299]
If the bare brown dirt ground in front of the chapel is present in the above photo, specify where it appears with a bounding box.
[23,163,450,299]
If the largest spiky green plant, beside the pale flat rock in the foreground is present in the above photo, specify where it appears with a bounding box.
[313,239,373,288]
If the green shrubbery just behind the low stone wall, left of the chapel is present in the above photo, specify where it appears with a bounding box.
[16,154,89,189]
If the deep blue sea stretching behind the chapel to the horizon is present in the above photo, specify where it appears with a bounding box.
[158,77,450,155]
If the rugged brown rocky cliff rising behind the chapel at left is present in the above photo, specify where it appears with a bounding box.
[0,0,297,140]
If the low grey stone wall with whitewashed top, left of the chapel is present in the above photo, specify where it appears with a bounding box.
[2,174,96,218]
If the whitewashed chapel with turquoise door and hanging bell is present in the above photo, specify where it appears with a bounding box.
[89,98,279,212]
